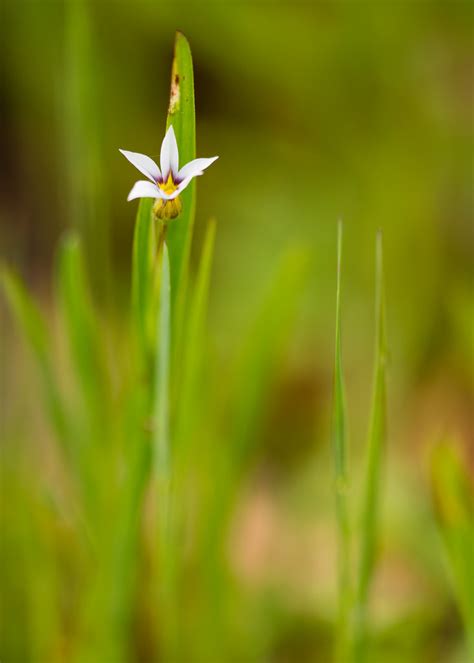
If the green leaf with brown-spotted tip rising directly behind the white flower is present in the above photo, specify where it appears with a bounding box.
[166,32,196,329]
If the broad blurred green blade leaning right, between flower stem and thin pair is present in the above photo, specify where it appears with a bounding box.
[194,249,308,660]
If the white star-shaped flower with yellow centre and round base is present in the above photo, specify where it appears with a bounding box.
[120,125,218,219]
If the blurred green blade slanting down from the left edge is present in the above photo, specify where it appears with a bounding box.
[0,266,68,446]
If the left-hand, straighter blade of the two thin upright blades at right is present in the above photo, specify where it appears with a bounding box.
[333,223,351,663]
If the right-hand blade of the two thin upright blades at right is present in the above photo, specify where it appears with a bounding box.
[354,233,387,661]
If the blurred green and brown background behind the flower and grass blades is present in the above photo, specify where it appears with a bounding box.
[0,0,474,663]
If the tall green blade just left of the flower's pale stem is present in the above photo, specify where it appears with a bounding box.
[90,198,159,661]
